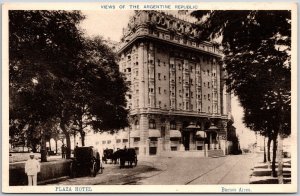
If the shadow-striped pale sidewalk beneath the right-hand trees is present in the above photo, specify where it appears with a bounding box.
[249,158,291,184]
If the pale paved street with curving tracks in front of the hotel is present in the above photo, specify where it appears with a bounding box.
[48,154,261,185]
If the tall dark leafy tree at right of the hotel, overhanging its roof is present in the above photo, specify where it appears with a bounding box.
[192,10,291,183]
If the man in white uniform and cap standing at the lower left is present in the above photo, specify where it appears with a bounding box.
[25,152,41,186]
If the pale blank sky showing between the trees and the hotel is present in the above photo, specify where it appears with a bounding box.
[80,10,259,147]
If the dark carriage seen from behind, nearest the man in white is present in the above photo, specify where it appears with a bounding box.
[70,147,103,178]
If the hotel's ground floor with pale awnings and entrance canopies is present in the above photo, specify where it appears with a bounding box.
[100,114,228,156]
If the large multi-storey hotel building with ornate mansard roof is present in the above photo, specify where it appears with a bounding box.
[98,10,231,156]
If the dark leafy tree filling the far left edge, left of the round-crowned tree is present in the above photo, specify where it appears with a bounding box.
[9,10,83,160]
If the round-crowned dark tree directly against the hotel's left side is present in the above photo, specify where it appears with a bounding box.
[71,37,128,146]
